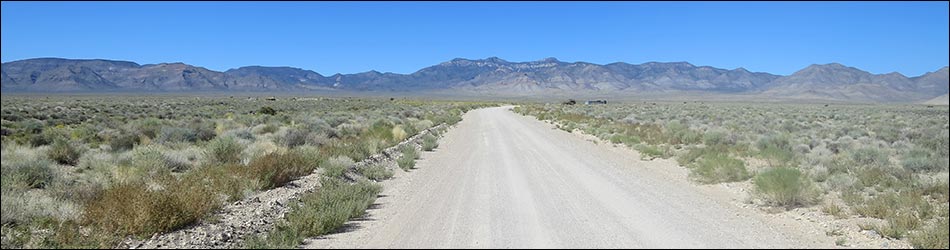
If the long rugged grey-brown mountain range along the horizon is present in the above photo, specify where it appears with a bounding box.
[0,57,950,102]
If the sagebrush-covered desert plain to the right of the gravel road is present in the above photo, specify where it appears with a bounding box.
[515,102,950,248]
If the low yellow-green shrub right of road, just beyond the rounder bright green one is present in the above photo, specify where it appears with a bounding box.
[690,154,751,184]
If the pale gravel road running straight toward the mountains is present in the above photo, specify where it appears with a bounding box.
[303,107,827,248]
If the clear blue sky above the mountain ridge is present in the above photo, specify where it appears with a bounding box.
[0,2,950,76]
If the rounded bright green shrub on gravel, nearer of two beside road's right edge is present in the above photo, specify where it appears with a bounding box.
[752,167,817,207]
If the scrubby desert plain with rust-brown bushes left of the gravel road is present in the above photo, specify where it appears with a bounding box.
[0,96,487,248]
